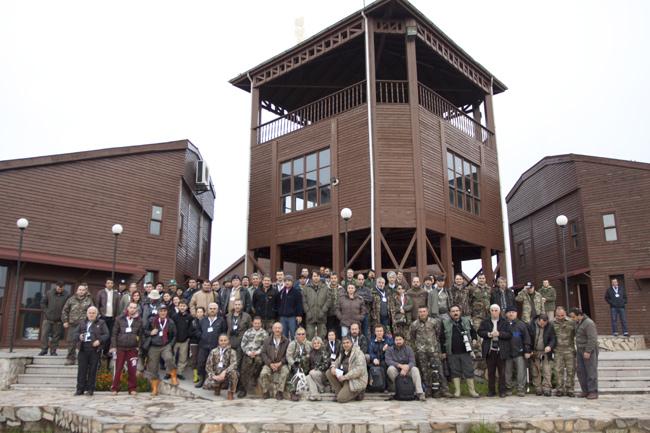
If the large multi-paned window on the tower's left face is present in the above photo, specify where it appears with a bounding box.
[280,149,332,214]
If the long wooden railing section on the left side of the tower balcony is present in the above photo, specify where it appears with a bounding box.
[257,81,367,143]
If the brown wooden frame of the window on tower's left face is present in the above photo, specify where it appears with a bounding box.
[277,146,332,217]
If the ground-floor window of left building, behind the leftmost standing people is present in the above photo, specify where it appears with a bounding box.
[17,280,72,341]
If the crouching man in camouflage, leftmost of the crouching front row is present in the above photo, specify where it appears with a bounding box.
[203,334,239,400]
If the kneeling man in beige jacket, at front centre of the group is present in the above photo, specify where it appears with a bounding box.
[326,336,368,403]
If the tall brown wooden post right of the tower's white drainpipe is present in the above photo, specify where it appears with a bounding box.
[405,19,427,278]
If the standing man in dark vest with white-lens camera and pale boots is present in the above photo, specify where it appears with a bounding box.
[440,305,479,398]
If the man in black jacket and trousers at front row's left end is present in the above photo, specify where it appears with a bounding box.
[72,307,110,395]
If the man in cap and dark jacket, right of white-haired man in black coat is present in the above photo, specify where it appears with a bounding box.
[506,305,530,397]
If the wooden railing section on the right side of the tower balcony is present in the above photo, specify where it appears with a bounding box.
[418,83,494,143]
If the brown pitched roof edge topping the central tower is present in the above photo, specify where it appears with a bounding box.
[229,0,507,94]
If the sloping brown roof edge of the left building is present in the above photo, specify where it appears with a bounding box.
[0,139,201,171]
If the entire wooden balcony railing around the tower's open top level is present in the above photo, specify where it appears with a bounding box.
[256,80,494,144]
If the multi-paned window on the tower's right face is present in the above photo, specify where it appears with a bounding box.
[447,152,481,215]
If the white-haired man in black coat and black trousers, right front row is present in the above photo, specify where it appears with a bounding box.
[478,304,512,397]
